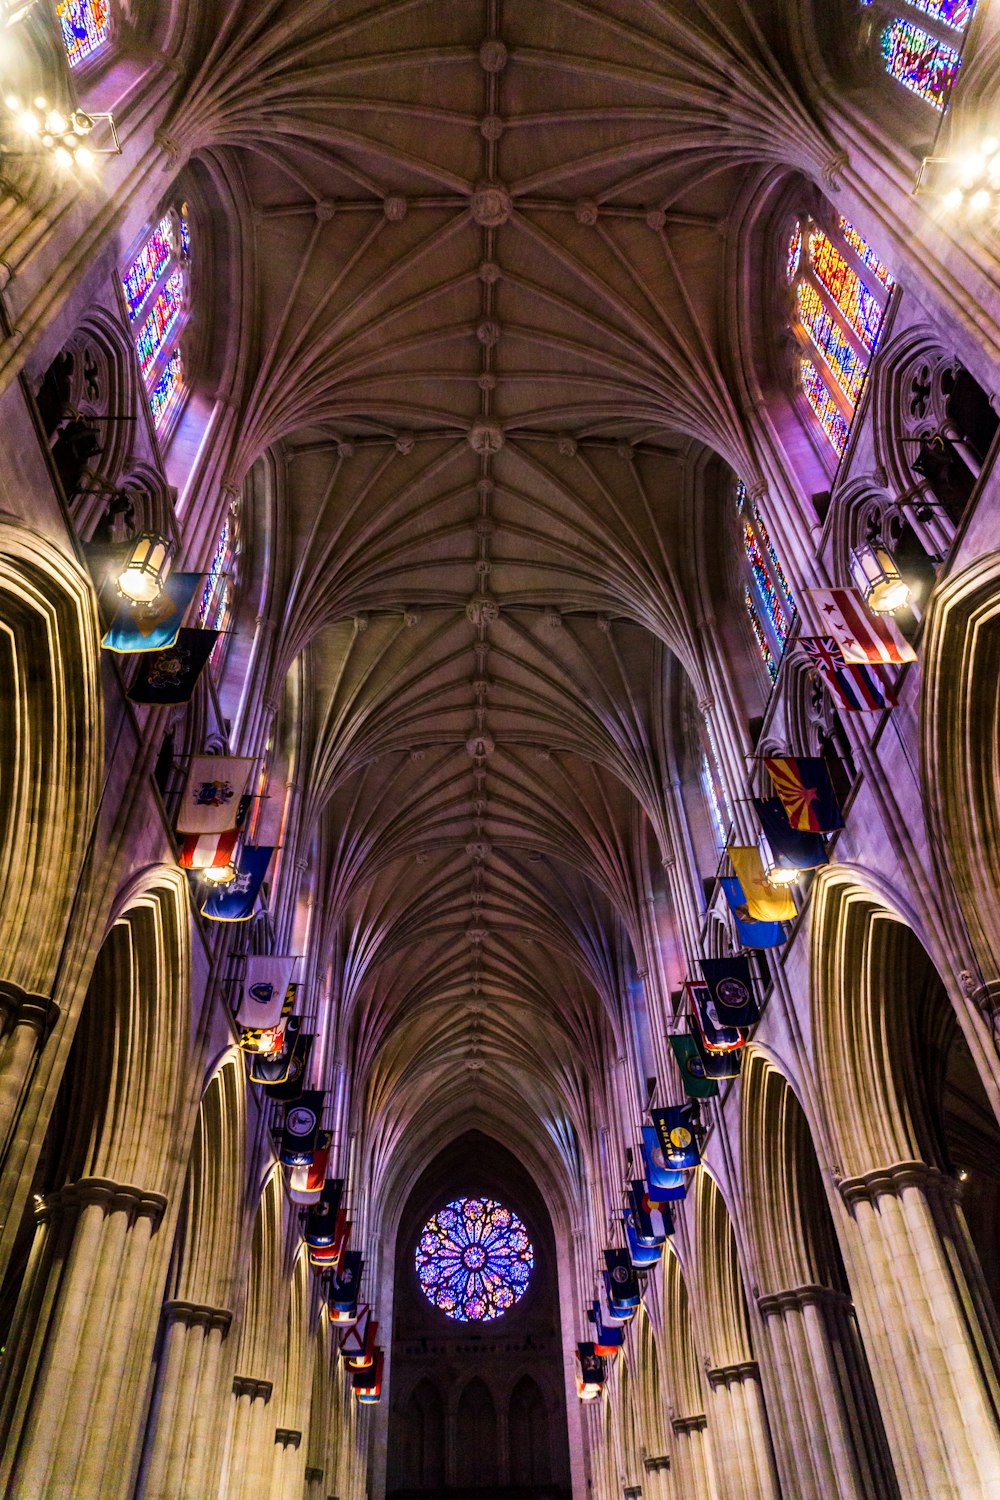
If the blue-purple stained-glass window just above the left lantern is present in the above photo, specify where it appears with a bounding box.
[121,207,190,434]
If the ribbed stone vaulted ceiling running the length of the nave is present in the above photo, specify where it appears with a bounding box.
[166,0,834,1194]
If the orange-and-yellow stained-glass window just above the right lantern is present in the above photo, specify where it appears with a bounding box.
[791,216,895,456]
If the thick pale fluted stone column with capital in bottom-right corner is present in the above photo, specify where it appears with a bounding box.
[838,1161,1000,1500]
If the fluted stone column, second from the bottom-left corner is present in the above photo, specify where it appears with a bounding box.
[136,1302,232,1500]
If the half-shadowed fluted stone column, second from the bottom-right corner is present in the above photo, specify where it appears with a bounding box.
[757,1286,899,1500]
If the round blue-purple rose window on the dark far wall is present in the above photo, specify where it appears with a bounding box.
[415,1199,535,1323]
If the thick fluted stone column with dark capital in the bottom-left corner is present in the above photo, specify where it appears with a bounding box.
[4,1178,166,1500]
